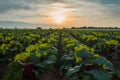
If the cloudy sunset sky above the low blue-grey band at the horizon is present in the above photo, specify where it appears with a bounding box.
[0,0,120,27]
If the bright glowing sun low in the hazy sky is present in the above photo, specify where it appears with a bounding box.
[51,11,66,24]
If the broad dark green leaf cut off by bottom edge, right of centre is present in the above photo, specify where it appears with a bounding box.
[87,69,112,80]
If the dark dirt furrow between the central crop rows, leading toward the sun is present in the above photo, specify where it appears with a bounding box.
[42,30,67,80]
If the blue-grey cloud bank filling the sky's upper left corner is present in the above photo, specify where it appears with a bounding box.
[0,0,68,13]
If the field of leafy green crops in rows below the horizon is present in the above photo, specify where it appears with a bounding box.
[0,29,120,80]
